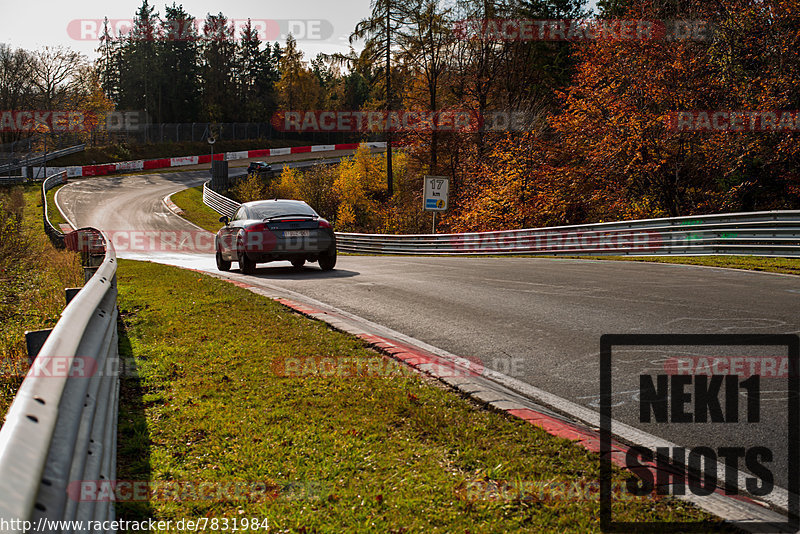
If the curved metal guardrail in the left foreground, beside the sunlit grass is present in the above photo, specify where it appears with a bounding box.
[0,228,119,533]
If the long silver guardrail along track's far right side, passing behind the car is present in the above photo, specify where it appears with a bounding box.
[203,183,800,257]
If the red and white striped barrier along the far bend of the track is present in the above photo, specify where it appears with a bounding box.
[34,142,386,178]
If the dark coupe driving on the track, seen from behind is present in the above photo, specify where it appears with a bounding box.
[214,199,336,274]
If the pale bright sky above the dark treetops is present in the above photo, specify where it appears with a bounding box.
[0,0,596,60]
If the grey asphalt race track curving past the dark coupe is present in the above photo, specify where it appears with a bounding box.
[58,162,800,494]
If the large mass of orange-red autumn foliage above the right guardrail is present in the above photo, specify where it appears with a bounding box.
[553,0,800,216]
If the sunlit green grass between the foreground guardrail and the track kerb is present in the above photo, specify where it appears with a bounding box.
[117,260,711,532]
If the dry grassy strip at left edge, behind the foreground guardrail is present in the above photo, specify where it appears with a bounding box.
[0,184,83,416]
